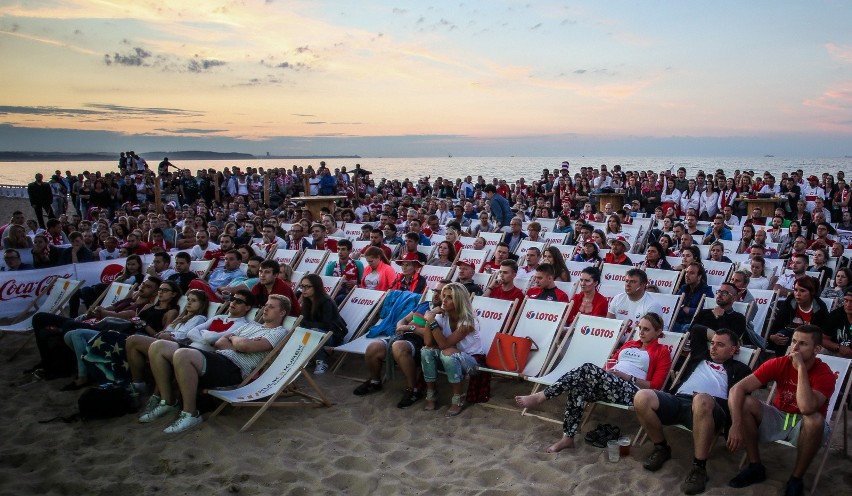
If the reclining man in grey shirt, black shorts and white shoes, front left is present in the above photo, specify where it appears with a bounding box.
[139,295,290,434]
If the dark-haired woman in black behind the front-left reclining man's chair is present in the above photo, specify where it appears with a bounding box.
[299,274,347,375]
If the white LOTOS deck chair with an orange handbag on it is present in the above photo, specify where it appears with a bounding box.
[480,298,571,378]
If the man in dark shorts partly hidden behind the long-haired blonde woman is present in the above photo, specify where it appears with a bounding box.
[353,279,451,408]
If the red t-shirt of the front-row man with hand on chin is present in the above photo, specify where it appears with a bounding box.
[754,356,835,417]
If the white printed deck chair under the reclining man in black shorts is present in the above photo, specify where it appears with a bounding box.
[206,327,331,432]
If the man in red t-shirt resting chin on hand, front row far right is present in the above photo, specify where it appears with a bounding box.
[728,325,835,495]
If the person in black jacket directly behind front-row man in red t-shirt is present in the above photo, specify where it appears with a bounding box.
[766,276,828,356]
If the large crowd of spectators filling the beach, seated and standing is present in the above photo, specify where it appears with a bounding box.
[0,157,852,494]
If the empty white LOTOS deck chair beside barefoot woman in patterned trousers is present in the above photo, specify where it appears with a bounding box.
[521,314,625,423]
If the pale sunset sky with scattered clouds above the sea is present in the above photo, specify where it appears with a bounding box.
[0,0,852,157]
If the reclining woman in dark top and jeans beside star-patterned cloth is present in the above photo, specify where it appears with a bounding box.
[62,278,181,391]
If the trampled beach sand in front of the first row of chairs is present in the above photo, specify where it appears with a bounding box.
[0,336,852,495]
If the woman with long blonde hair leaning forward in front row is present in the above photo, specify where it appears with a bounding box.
[420,282,485,417]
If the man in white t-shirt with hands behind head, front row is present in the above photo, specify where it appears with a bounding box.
[633,326,751,494]
